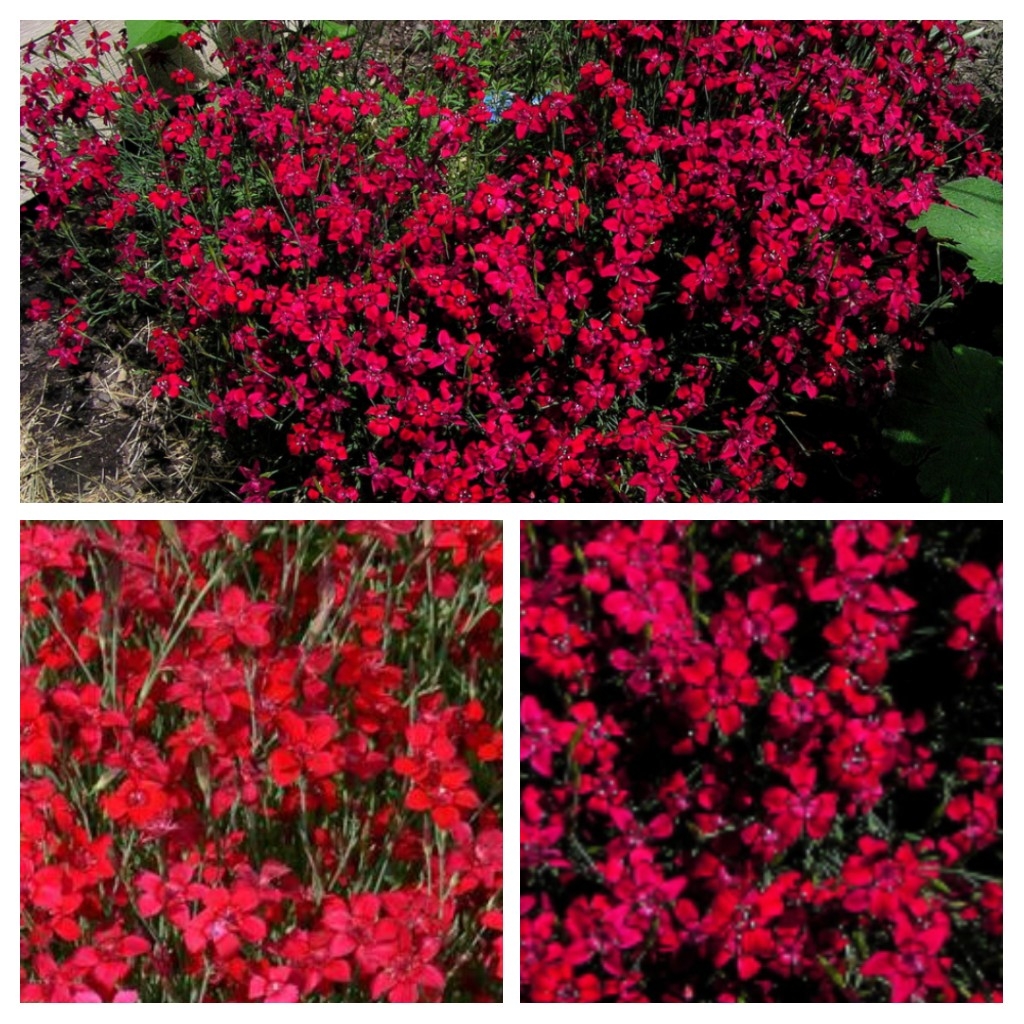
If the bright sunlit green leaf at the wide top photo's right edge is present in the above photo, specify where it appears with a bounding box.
[908,178,1002,285]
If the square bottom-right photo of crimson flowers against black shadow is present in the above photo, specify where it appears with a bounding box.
[519,520,1002,1002]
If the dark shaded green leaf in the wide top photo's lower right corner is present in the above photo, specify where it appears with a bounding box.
[883,344,1002,502]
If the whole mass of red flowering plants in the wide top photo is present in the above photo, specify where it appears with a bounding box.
[22,20,1001,501]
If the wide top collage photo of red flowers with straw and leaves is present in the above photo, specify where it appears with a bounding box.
[20,18,1002,504]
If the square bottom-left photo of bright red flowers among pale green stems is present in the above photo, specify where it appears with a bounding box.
[20,520,502,1002]
